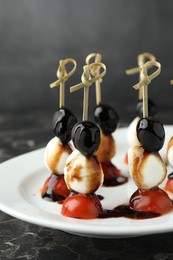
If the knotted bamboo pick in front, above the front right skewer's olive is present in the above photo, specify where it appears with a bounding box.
[133,61,161,117]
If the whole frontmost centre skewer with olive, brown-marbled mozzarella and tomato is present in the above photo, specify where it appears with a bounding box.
[61,63,106,219]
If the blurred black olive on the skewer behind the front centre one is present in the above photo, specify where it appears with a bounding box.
[94,104,119,135]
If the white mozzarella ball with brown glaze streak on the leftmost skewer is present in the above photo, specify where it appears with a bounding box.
[44,137,72,175]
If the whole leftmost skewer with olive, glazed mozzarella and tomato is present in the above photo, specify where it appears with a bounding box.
[42,59,77,201]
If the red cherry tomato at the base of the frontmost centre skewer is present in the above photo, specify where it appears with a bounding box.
[61,193,102,219]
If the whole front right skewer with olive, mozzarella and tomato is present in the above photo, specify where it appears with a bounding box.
[128,61,172,215]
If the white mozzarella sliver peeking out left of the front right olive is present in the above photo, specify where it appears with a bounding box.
[127,117,141,146]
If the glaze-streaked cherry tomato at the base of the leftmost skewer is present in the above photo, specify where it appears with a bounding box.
[41,174,70,201]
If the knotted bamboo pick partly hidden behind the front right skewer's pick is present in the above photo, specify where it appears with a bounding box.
[126,52,156,102]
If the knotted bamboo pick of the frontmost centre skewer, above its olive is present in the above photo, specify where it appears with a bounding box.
[70,62,106,121]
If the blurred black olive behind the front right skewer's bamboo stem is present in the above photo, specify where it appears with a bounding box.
[136,99,158,118]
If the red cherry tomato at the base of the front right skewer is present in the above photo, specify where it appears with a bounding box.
[130,187,172,215]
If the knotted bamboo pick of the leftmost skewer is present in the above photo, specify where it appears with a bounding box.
[50,58,77,108]
